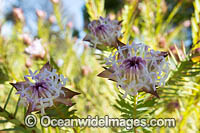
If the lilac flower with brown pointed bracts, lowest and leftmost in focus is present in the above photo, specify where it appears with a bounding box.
[11,63,80,114]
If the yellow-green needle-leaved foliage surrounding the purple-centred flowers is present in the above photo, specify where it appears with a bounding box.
[0,0,200,133]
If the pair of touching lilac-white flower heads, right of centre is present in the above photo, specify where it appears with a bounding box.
[84,17,169,98]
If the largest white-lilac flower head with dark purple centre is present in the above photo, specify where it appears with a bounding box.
[98,43,169,98]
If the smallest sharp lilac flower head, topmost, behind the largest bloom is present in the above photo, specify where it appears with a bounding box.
[83,17,122,49]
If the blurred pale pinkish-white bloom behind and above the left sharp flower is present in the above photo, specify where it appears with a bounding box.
[25,39,46,58]
